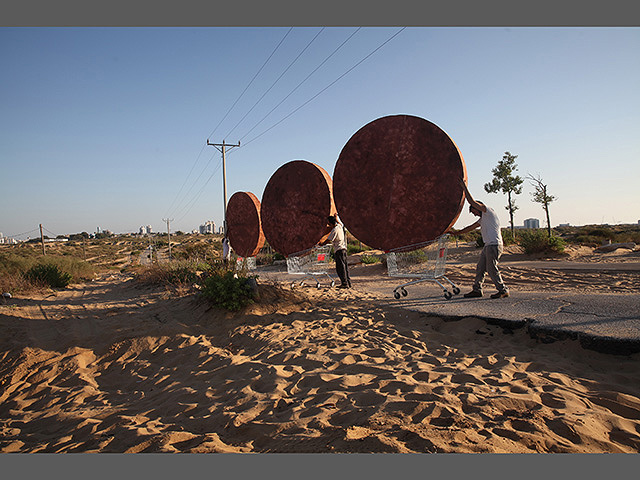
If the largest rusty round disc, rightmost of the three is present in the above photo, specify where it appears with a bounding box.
[333,115,467,251]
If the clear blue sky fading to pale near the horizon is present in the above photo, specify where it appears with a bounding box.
[0,27,640,239]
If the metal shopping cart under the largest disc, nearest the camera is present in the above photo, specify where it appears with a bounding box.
[387,234,460,300]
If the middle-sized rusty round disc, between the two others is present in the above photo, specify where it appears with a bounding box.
[260,160,336,256]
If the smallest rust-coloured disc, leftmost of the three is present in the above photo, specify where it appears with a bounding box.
[227,192,264,257]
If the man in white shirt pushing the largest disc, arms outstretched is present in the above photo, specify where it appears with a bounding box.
[449,180,509,298]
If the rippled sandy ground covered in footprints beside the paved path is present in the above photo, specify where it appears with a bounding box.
[0,248,640,453]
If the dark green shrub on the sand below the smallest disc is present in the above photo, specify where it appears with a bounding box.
[202,269,255,311]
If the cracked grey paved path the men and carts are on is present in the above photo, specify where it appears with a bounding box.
[257,262,640,355]
